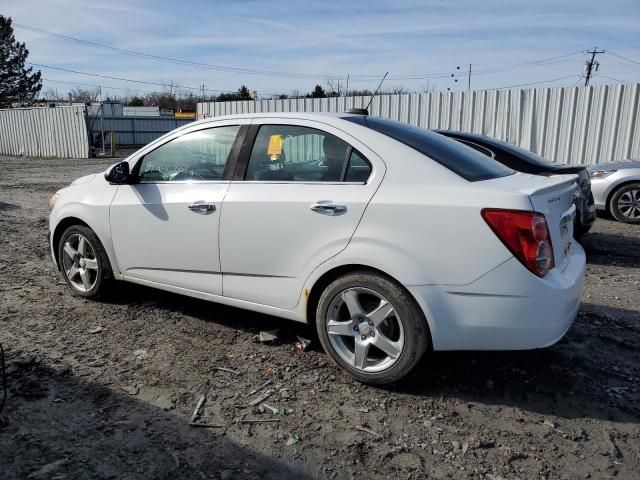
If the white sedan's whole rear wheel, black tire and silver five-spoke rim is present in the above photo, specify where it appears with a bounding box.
[316,271,430,384]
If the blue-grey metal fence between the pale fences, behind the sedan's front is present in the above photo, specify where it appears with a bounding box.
[87,116,193,147]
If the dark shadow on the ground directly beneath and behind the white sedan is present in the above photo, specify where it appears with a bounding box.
[97,284,640,423]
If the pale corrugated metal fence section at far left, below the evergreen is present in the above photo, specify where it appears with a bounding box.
[0,107,89,158]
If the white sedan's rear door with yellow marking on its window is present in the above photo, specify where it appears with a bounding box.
[220,118,385,308]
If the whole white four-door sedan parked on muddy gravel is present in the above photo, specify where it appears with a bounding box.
[50,113,585,383]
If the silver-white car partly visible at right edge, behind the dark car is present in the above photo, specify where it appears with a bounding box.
[587,160,640,224]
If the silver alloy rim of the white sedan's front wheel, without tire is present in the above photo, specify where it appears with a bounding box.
[62,233,98,293]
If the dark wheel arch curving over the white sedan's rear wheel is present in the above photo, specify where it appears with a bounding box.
[305,263,433,345]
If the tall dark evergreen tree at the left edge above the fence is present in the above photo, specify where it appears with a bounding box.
[0,15,42,107]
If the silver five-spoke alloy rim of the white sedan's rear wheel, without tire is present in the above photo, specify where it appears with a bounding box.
[325,287,405,373]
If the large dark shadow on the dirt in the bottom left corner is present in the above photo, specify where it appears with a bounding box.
[0,351,315,479]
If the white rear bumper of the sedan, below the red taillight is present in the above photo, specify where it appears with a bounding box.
[408,242,585,350]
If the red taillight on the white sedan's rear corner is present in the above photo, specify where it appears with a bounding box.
[482,208,554,277]
